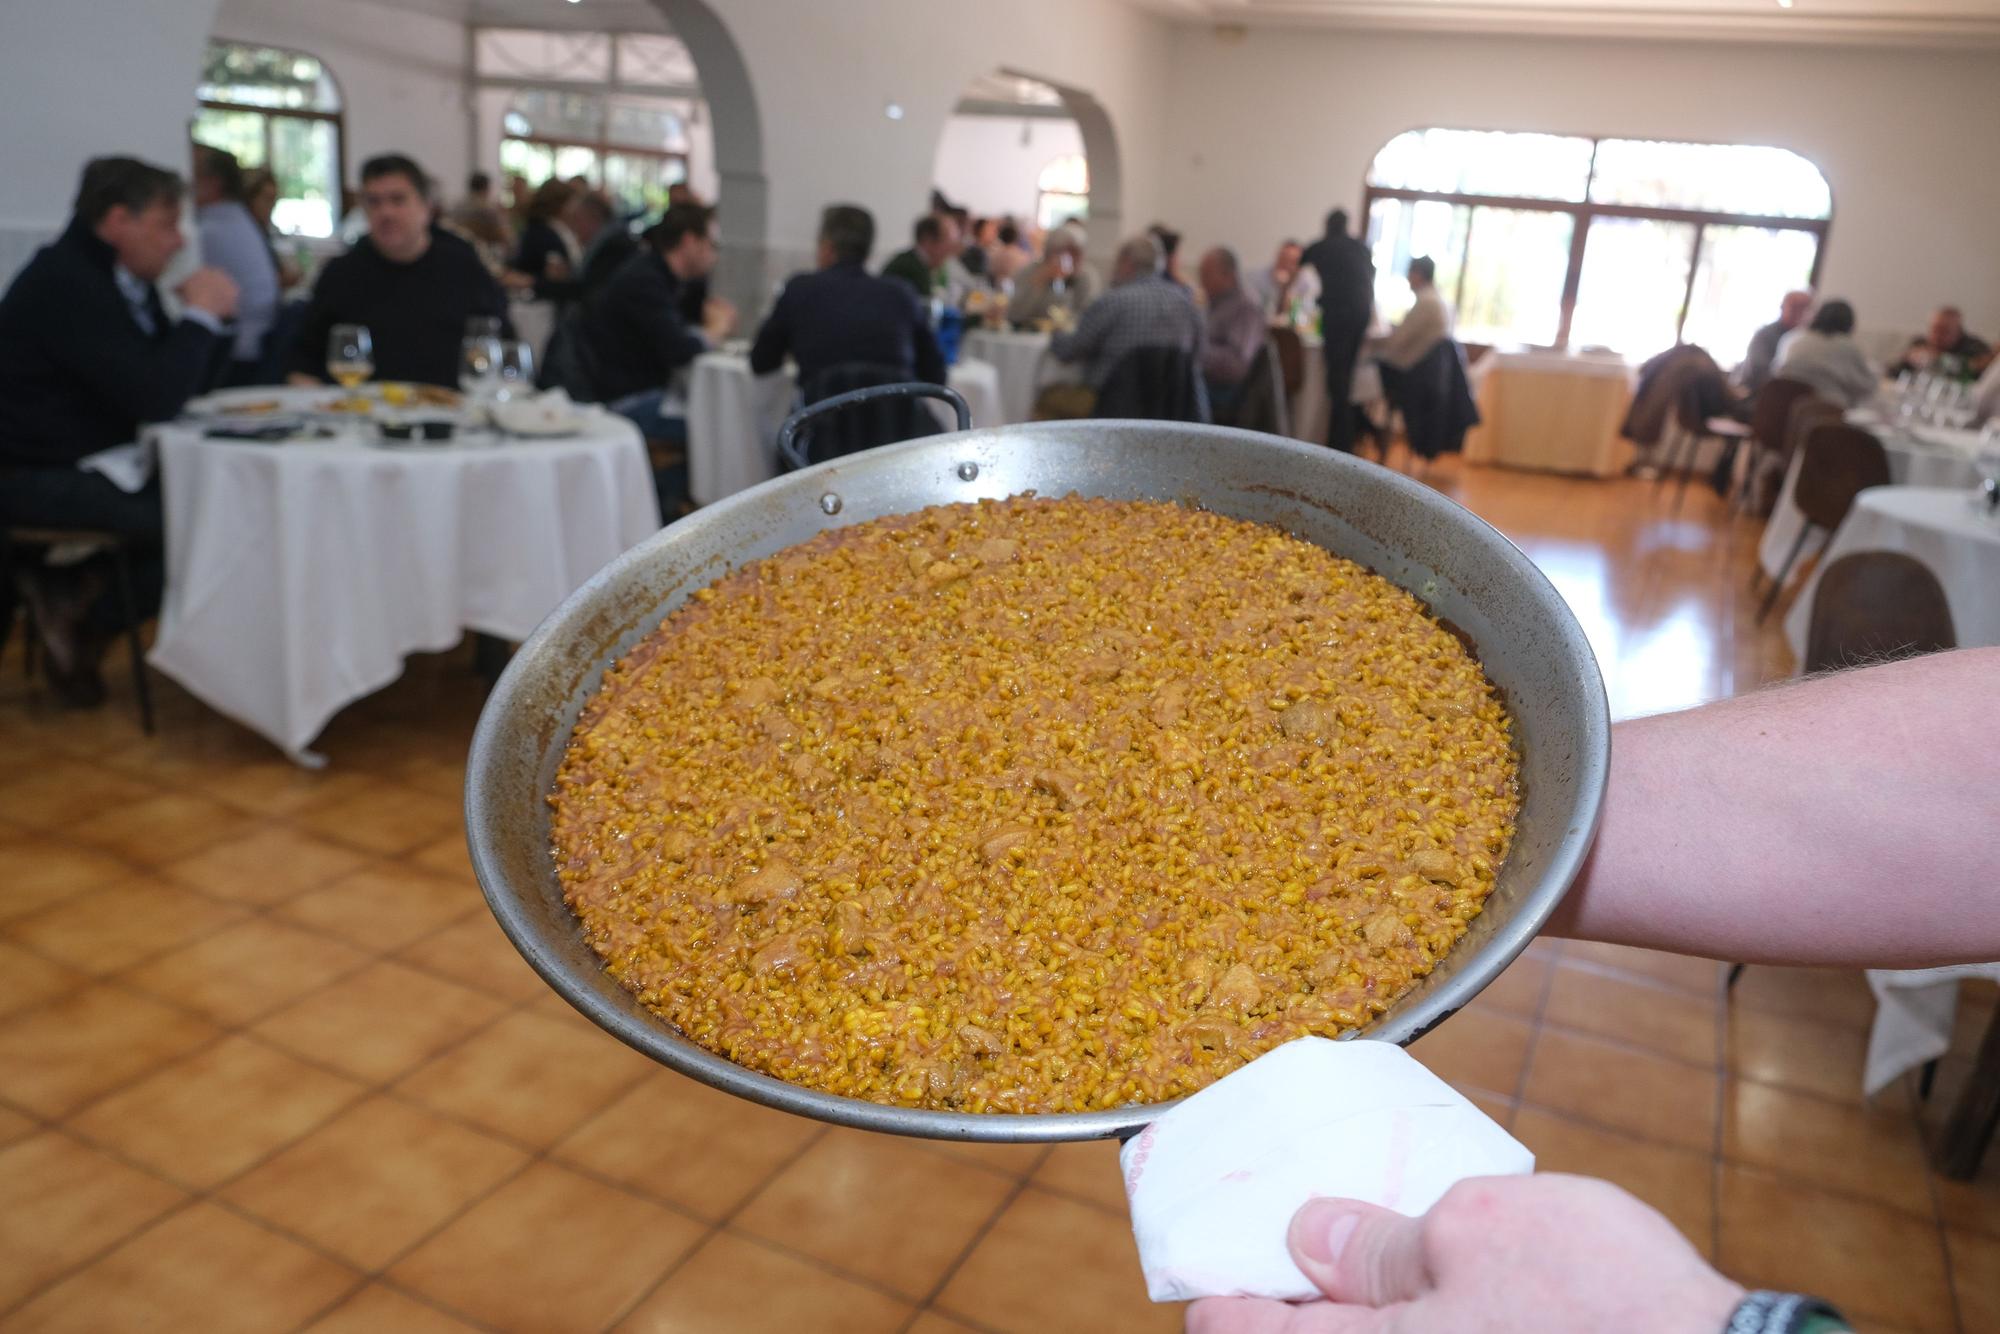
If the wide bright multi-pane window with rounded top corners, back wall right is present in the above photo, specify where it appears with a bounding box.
[1366,130,1832,366]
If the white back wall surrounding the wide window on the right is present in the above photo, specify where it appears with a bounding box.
[1162,28,2000,334]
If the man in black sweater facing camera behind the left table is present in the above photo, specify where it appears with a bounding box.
[290,154,512,388]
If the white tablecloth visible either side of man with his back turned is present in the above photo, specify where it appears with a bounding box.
[688,352,1006,504]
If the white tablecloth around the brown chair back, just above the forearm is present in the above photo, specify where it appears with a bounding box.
[1784,486,2000,662]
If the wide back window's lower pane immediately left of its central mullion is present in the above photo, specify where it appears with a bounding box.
[1438,208,1574,348]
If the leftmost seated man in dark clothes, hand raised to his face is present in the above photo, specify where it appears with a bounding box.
[0,158,236,704]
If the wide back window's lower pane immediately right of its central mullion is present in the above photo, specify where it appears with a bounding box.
[1570,218,1694,360]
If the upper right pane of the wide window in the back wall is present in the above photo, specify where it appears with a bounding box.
[1590,138,1834,218]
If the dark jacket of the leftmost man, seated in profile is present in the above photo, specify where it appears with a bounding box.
[0,222,216,468]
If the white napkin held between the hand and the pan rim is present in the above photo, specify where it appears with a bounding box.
[1120,1038,1534,1302]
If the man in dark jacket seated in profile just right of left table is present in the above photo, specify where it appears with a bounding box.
[580,204,736,444]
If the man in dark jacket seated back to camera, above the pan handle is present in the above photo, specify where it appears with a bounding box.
[750,204,944,394]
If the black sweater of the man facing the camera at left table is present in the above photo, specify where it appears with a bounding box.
[288,228,512,386]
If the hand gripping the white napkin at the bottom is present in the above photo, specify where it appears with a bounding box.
[1188,1176,1744,1334]
